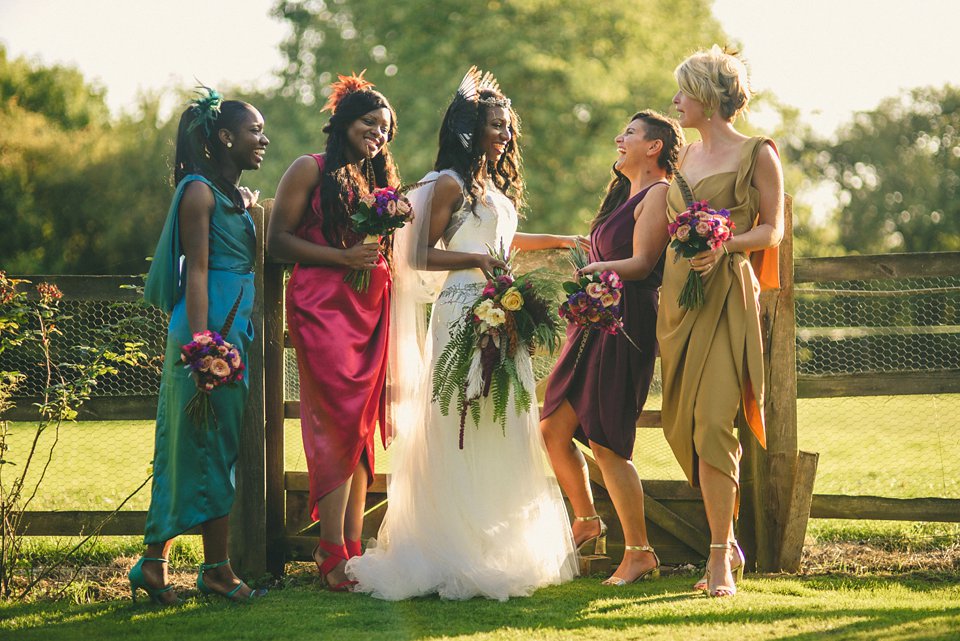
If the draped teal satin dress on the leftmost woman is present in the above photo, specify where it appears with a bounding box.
[144,174,256,545]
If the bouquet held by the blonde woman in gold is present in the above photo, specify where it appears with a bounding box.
[667,200,735,309]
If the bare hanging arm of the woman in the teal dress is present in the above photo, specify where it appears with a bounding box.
[177,180,216,334]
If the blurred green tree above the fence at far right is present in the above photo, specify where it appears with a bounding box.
[805,86,960,253]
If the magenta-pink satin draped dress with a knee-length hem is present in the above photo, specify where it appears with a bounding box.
[287,154,391,520]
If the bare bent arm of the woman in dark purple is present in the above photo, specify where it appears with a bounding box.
[582,185,670,280]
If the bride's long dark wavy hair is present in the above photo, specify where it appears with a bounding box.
[433,89,524,211]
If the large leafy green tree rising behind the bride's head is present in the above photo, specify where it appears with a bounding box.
[275,0,724,232]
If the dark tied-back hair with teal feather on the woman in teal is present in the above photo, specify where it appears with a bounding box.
[173,87,253,211]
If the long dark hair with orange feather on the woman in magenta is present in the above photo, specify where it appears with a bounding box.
[320,83,400,247]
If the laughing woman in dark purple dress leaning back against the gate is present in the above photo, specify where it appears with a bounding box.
[540,111,683,585]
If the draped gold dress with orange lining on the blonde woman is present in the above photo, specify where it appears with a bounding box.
[657,137,779,487]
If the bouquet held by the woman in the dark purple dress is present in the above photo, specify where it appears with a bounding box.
[560,245,639,367]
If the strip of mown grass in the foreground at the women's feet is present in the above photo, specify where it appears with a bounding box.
[0,577,960,641]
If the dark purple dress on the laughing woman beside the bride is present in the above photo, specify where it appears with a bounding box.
[542,183,663,459]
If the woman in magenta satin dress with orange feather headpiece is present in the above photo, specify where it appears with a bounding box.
[267,74,399,591]
